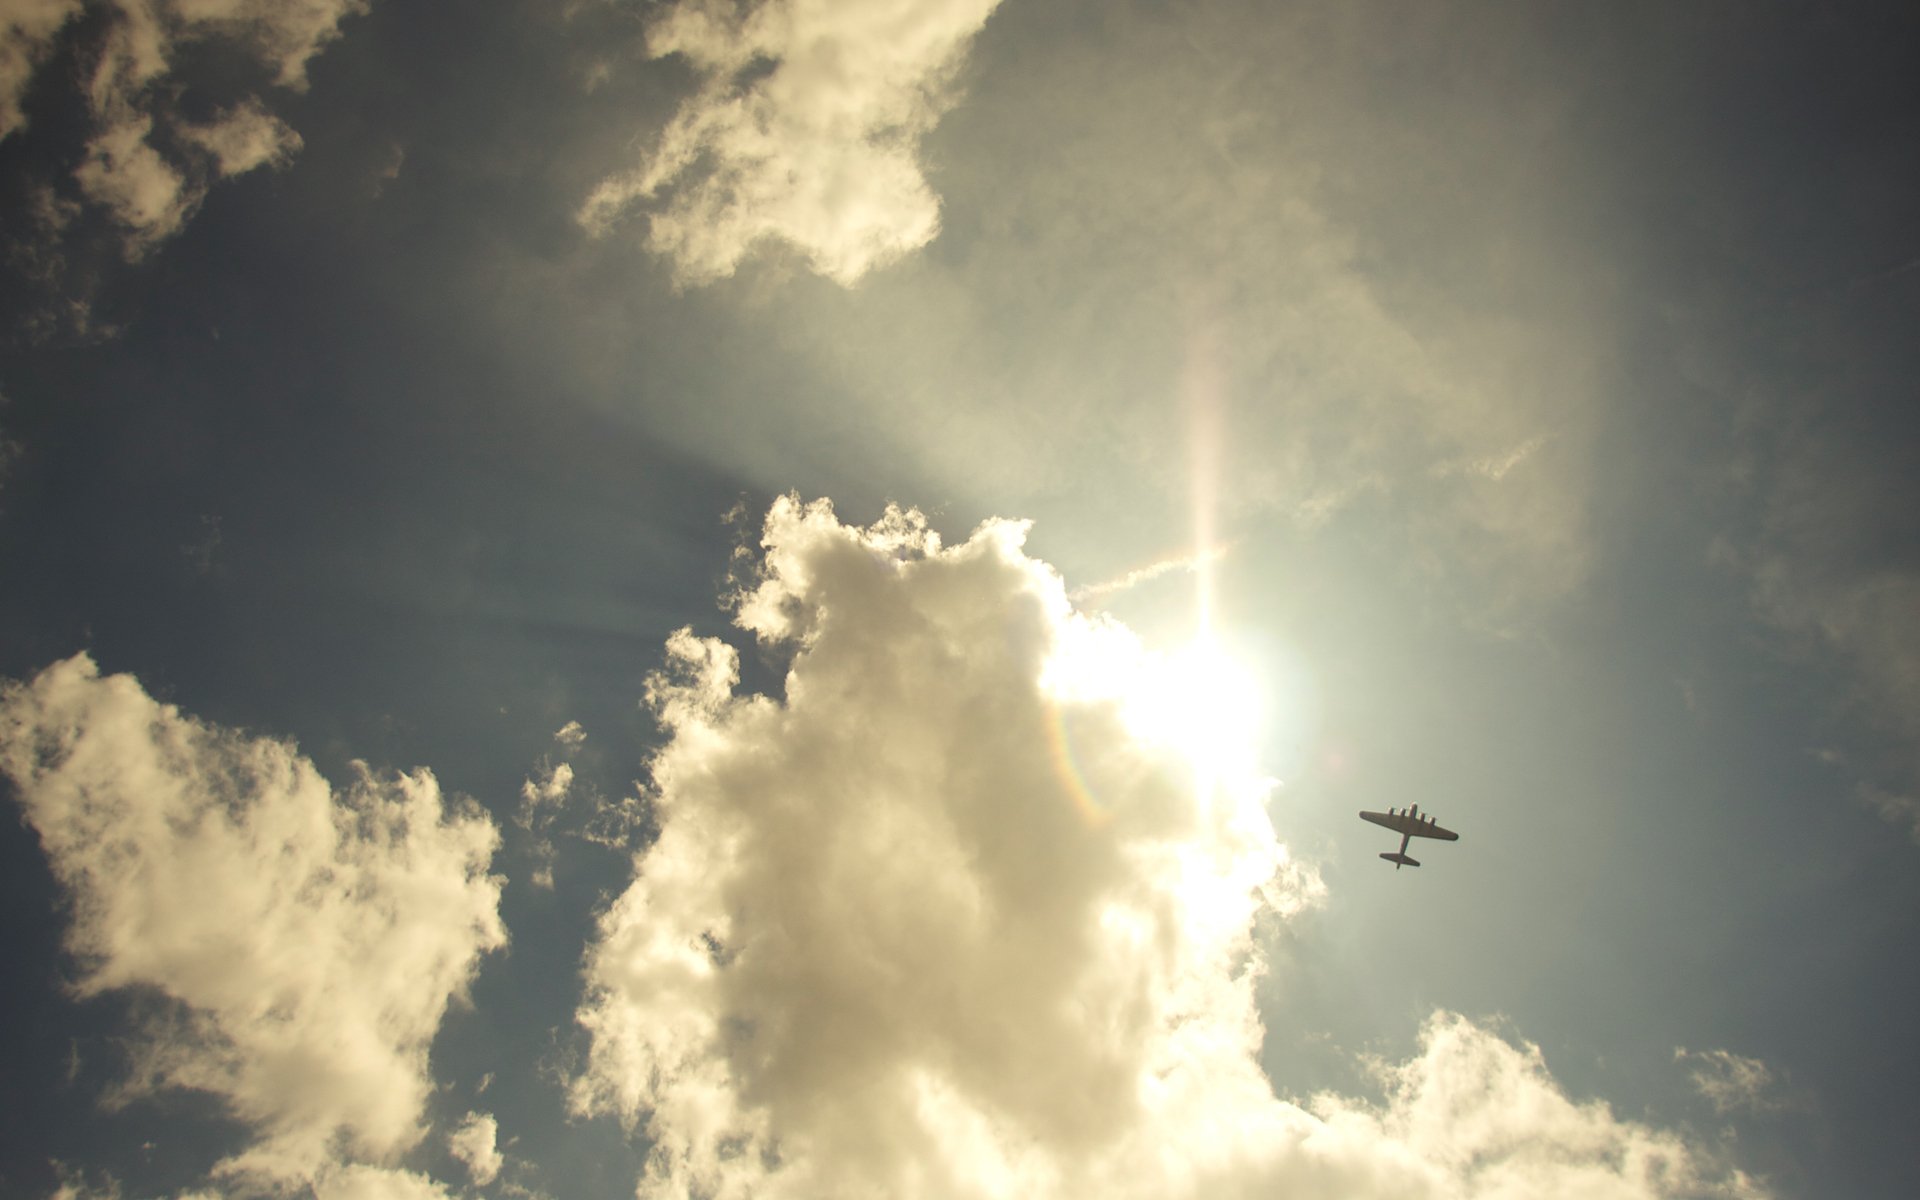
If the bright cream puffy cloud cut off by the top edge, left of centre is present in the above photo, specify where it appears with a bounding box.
[580,0,998,286]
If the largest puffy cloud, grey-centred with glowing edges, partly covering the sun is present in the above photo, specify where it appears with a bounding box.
[572,497,1763,1198]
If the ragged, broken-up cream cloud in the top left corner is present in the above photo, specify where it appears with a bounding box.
[0,0,367,257]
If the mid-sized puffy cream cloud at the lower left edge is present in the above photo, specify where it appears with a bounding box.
[0,655,505,1196]
